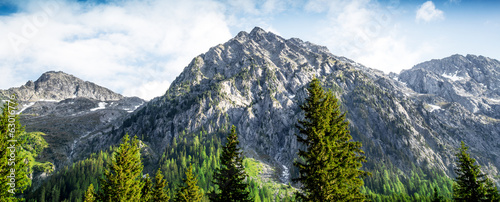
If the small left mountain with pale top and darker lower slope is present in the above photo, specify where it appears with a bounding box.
[0,71,145,169]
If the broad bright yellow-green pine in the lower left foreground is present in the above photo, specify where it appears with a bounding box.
[99,135,144,202]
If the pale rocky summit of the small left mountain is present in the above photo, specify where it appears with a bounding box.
[0,71,123,102]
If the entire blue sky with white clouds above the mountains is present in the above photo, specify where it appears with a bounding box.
[0,0,500,99]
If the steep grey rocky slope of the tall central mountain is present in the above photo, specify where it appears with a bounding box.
[103,28,494,188]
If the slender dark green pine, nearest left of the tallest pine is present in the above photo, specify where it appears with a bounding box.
[209,126,253,202]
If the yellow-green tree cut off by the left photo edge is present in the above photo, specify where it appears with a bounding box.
[0,95,31,201]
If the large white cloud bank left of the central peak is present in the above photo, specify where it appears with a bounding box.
[0,0,231,99]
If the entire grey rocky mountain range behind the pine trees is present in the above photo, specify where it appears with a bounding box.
[4,27,500,194]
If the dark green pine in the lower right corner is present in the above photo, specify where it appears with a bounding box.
[453,141,487,202]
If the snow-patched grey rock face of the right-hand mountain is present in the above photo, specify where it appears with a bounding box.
[399,55,500,176]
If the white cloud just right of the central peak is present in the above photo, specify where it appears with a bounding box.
[305,0,433,73]
